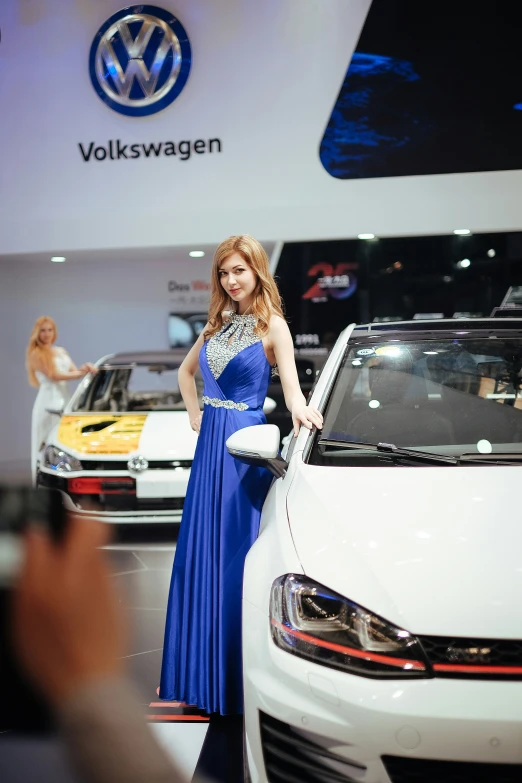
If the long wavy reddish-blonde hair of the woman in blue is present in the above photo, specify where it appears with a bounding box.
[204,234,284,340]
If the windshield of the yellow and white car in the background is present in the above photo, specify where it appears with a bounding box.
[73,364,201,413]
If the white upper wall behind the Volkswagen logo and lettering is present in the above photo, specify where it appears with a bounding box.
[0,0,522,254]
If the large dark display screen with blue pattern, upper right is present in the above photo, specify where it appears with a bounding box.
[320,0,522,179]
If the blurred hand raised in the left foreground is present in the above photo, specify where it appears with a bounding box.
[12,517,126,707]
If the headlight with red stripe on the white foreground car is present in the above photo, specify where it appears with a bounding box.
[270,574,426,677]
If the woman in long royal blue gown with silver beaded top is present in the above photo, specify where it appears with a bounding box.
[160,235,322,715]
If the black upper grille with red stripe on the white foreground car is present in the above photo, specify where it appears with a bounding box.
[418,636,522,679]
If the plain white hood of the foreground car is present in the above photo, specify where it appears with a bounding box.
[287,463,522,639]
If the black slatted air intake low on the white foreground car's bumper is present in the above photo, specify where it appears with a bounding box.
[259,712,366,783]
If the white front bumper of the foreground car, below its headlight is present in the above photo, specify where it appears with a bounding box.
[243,600,522,783]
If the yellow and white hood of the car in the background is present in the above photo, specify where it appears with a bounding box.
[48,411,197,460]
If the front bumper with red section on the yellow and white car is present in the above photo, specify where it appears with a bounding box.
[36,468,184,524]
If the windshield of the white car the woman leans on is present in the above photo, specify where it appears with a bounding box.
[311,335,522,464]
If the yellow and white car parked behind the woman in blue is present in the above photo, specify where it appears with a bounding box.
[37,350,200,523]
